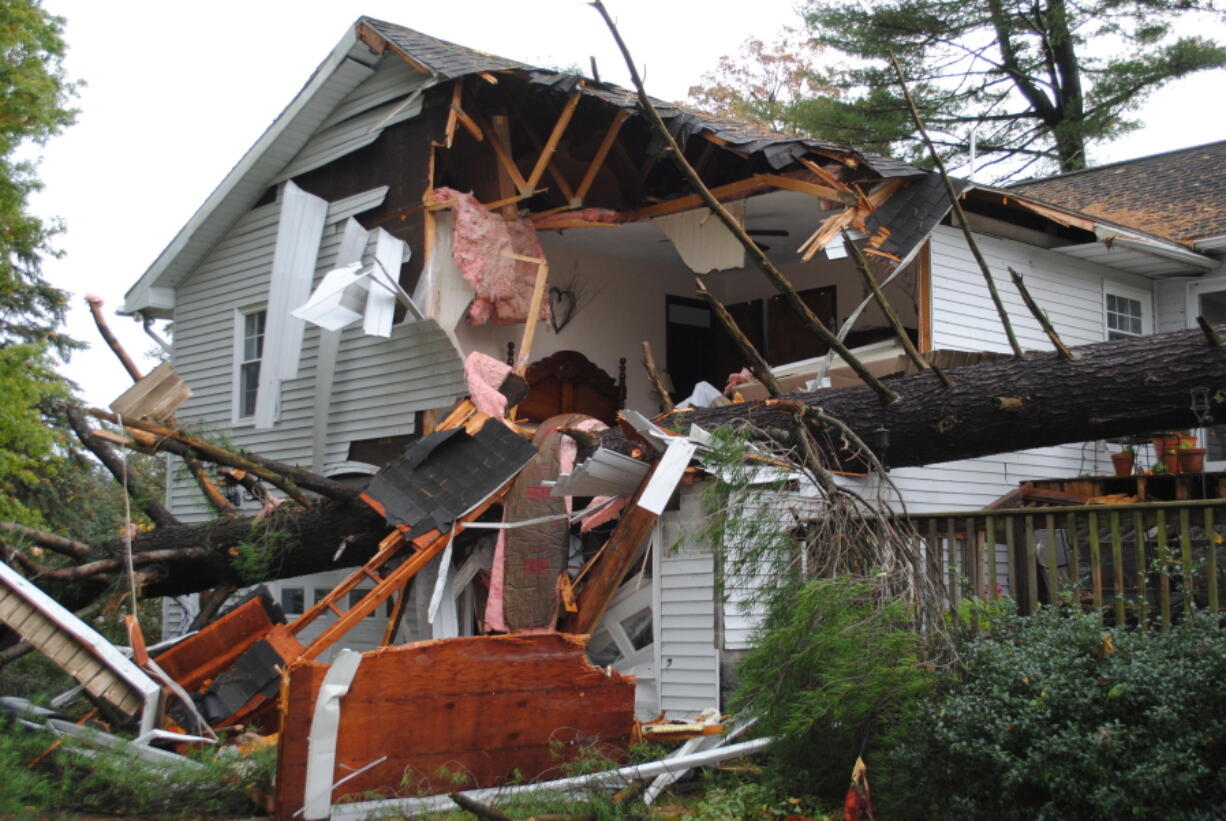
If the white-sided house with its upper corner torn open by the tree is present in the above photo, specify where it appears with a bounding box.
[123,17,1226,716]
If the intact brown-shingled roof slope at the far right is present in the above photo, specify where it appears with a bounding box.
[1011,140,1226,245]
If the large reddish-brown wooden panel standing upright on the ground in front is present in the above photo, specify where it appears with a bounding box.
[277,634,634,820]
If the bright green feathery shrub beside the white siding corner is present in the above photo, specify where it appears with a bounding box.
[733,578,934,801]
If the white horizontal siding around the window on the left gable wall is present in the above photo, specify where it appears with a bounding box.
[168,192,466,521]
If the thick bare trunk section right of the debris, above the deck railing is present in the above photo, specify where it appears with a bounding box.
[637,328,1226,467]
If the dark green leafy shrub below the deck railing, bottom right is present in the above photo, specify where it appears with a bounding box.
[887,609,1226,819]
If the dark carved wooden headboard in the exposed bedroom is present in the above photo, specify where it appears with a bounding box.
[515,350,625,425]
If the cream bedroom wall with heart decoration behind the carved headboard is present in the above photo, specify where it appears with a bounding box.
[455,240,694,414]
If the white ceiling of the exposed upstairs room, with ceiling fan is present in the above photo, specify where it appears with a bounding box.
[541,191,834,265]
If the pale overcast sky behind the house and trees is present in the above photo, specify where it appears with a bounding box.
[34,0,1226,404]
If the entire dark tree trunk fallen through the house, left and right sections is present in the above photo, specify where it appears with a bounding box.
[11,328,1226,600]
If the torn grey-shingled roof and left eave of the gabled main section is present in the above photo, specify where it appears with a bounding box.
[120,17,1211,316]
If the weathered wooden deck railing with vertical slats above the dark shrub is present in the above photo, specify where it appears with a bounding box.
[908,499,1226,626]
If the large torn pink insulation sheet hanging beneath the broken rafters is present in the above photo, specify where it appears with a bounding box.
[434,187,549,325]
